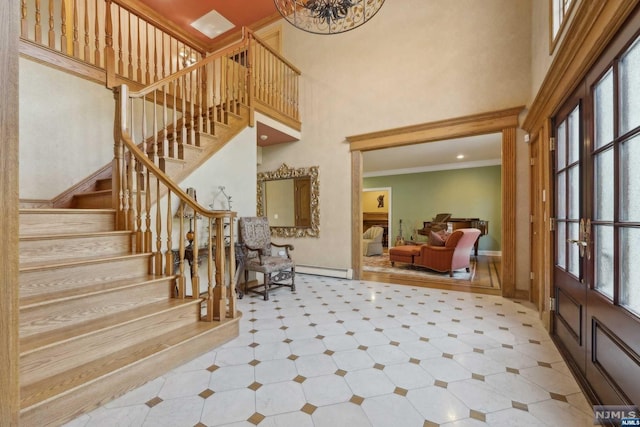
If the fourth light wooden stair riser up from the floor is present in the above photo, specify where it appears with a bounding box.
[20,255,150,305]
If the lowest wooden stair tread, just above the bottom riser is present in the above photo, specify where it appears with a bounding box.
[20,320,230,408]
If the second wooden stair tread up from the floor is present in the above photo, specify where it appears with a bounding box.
[20,298,192,354]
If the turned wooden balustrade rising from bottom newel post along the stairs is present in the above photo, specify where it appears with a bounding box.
[112,31,249,321]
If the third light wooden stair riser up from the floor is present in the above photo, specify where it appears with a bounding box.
[20,278,173,339]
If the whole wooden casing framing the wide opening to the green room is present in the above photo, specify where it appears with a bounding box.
[346,107,528,299]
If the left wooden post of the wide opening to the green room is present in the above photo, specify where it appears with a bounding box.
[351,150,362,280]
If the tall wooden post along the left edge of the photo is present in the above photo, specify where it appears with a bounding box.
[0,1,20,426]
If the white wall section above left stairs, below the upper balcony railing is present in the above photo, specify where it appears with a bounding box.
[19,58,115,200]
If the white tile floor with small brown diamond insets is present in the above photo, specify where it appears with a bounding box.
[66,275,593,427]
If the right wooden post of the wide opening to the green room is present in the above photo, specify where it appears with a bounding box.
[501,127,516,298]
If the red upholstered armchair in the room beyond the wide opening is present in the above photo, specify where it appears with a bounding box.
[414,228,480,277]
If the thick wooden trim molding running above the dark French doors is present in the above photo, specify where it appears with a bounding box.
[522,0,640,133]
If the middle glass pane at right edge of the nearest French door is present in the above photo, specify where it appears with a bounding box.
[620,136,640,221]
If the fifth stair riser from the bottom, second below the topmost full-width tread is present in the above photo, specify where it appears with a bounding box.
[20,234,131,264]
